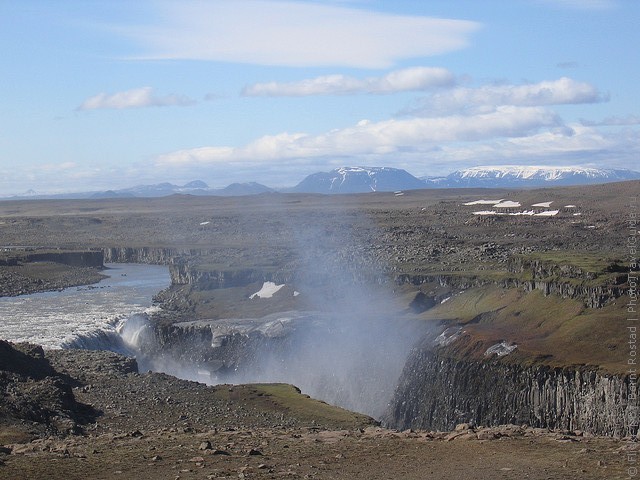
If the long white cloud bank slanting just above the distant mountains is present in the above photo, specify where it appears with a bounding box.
[156,106,559,166]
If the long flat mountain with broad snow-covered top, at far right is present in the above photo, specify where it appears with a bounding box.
[424,165,640,188]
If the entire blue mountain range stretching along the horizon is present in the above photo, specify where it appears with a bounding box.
[10,165,640,199]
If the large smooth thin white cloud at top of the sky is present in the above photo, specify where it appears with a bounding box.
[121,0,480,68]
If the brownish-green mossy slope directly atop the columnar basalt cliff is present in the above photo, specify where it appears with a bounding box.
[422,286,629,374]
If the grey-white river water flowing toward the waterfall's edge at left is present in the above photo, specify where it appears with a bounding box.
[0,263,170,348]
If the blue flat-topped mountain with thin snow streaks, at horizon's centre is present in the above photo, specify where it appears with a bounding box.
[289,167,427,193]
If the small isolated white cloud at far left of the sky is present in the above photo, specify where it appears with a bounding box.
[78,87,195,110]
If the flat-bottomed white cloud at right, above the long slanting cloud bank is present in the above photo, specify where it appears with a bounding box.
[409,77,607,114]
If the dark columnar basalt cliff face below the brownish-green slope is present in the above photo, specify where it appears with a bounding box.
[383,348,637,436]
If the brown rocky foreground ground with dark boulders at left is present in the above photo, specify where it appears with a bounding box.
[0,342,635,480]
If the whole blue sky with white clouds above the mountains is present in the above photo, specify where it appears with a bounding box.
[0,0,640,196]
